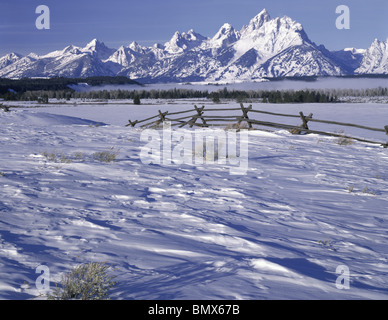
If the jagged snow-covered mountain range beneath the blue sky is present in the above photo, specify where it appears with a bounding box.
[0,9,388,83]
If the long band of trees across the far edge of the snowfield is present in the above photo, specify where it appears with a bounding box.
[0,87,388,103]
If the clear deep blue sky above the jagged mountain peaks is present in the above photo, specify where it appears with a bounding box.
[0,0,388,55]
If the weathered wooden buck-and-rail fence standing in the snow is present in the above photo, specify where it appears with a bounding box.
[126,104,388,148]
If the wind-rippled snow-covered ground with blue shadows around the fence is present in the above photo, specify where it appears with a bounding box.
[0,105,388,299]
